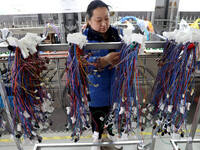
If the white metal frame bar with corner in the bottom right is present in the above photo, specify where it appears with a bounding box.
[170,139,200,150]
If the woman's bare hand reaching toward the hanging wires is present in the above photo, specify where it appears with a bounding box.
[101,52,120,68]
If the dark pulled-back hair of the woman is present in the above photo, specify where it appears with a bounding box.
[86,0,109,19]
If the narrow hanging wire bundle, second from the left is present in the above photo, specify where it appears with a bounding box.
[66,44,89,141]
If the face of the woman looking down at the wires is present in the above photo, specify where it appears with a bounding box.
[88,7,110,33]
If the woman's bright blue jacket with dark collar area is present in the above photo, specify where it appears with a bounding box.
[83,26,121,107]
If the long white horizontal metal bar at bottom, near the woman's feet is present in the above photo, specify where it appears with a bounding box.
[33,140,143,150]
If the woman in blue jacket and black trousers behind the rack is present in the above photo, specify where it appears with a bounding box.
[83,0,121,149]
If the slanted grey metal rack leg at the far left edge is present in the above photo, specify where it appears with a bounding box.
[0,79,23,150]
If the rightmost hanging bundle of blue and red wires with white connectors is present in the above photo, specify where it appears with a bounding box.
[148,41,195,136]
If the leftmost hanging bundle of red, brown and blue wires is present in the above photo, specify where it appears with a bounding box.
[11,47,54,142]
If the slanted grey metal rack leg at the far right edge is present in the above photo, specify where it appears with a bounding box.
[185,97,200,150]
